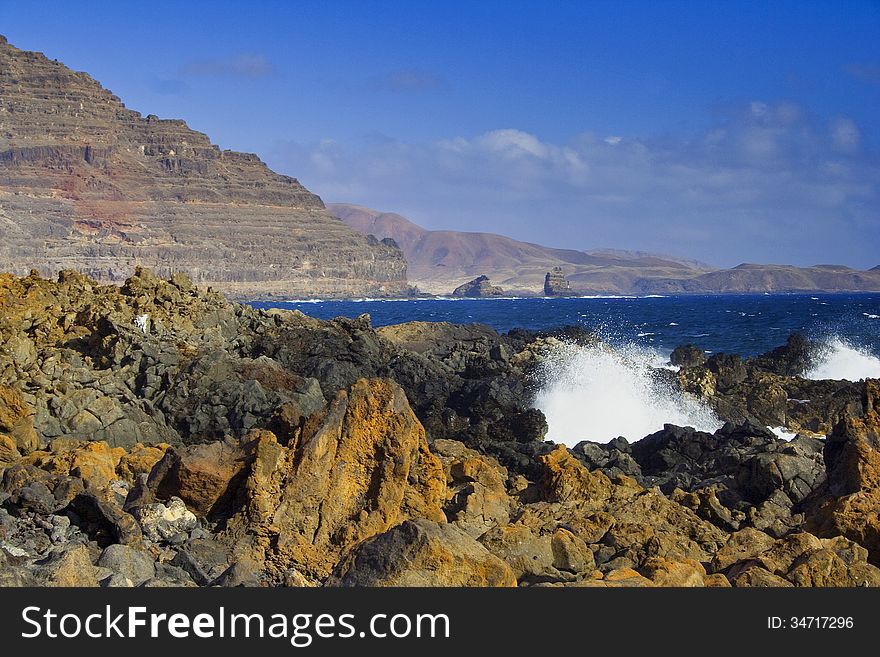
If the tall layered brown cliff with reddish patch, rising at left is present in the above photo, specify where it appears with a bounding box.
[0,37,406,298]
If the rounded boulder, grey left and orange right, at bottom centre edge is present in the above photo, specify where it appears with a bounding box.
[327,520,516,586]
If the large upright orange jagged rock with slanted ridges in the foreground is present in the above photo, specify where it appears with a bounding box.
[223,379,446,577]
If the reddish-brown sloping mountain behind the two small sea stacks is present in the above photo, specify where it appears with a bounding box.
[327,203,710,294]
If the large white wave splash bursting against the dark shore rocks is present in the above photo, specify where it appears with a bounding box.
[535,344,721,446]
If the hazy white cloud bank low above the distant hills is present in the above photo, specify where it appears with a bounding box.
[269,102,880,266]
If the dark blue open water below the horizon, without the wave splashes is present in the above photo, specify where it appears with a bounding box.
[252,293,880,355]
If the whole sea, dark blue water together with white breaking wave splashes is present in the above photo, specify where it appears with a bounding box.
[252,293,880,446]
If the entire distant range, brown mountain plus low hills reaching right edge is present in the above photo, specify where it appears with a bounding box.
[327,203,880,294]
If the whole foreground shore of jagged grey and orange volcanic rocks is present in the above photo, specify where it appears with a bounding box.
[0,270,880,586]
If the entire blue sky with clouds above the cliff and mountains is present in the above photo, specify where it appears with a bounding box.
[0,0,880,268]
